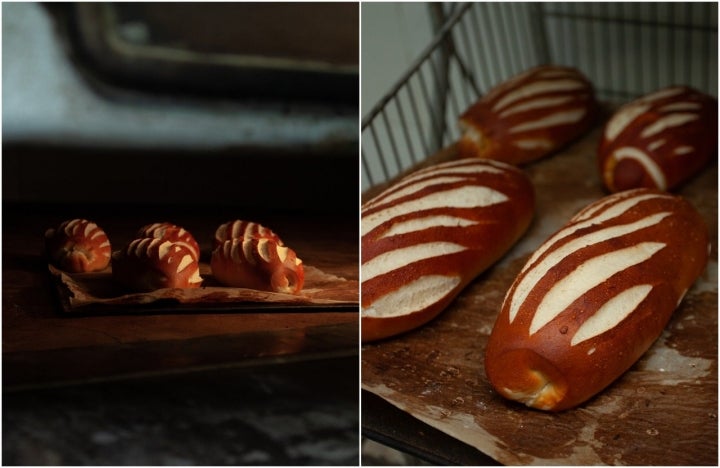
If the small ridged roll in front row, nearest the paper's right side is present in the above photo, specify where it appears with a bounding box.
[210,237,305,294]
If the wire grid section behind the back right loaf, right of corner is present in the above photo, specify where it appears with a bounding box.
[542,2,718,102]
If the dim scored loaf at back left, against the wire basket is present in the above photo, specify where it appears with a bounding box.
[458,65,598,164]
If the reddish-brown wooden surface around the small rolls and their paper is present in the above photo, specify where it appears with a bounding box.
[2,205,358,389]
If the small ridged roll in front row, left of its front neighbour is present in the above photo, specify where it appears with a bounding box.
[112,237,202,291]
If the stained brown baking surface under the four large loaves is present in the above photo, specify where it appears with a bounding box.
[361,128,718,465]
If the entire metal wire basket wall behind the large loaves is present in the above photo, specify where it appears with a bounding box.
[361,2,718,190]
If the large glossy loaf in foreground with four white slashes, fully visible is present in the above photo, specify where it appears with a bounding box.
[485,189,709,411]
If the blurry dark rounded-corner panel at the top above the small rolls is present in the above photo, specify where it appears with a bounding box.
[60,2,359,101]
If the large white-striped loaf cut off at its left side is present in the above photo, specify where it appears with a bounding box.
[361,159,535,341]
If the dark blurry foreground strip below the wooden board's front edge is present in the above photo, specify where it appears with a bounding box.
[2,356,359,466]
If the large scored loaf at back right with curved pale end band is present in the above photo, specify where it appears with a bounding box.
[598,86,718,192]
